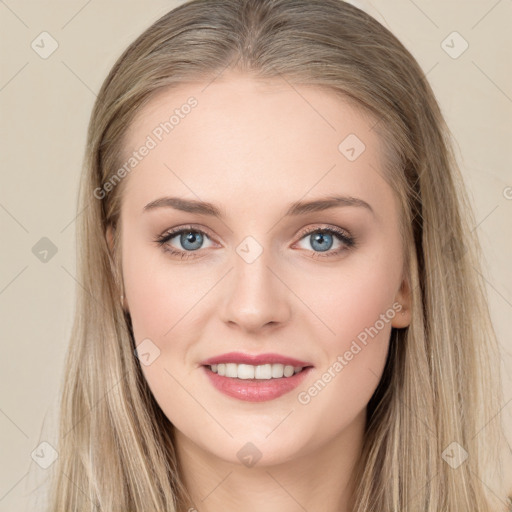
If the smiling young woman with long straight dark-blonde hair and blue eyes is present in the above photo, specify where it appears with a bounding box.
[46,0,508,512]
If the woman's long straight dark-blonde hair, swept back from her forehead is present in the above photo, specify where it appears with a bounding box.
[46,0,506,512]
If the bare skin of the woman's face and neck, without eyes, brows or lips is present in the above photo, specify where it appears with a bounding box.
[108,72,410,512]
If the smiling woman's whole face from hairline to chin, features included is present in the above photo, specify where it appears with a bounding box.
[109,74,409,465]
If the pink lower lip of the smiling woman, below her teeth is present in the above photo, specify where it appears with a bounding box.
[203,366,313,402]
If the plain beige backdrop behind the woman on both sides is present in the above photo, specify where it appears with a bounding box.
[0,0,512,511]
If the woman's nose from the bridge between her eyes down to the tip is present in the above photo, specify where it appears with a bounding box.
[221,237,290,330]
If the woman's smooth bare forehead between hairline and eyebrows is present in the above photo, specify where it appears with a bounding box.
[119,74,392,216]
